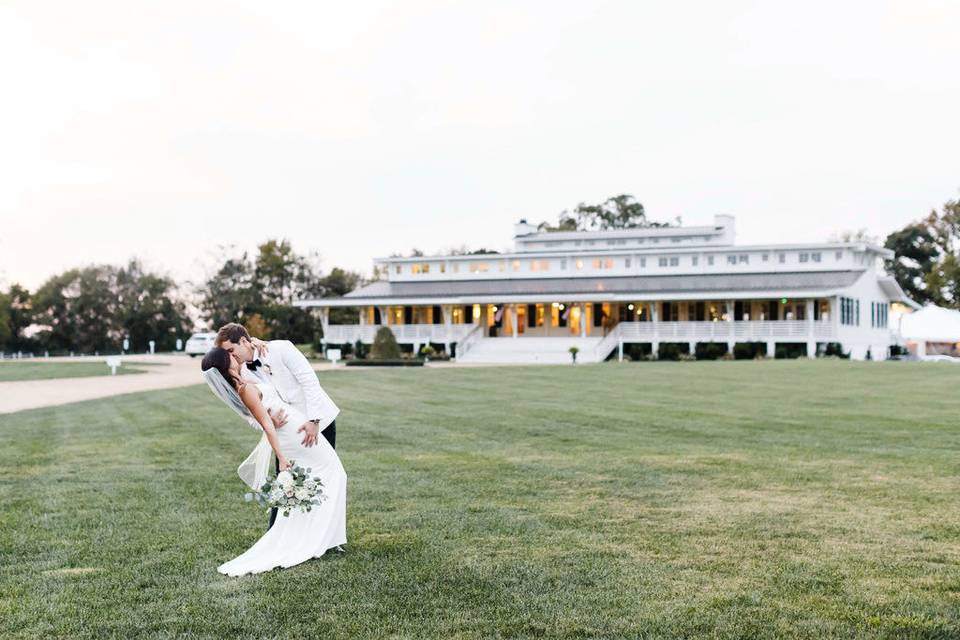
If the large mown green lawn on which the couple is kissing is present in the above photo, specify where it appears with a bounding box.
[0,361,960,638]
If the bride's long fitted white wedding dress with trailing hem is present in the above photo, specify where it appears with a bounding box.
[217,383,347,576]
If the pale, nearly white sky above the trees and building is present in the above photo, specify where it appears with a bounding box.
[0,0,960,288]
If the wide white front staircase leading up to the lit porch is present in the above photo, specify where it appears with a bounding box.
[457,336,616,364]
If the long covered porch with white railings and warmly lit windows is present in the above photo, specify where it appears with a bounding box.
[320,298,837,355]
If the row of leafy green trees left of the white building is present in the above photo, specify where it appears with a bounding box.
[0,240,363,353]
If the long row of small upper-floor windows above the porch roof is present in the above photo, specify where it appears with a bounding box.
[394,251,843,274]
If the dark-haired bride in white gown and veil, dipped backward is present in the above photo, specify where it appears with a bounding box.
[201,347,347,576]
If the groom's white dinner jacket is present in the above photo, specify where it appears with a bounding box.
[242,340,340,431]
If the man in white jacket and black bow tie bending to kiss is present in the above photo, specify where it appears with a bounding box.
[216,322,340,529]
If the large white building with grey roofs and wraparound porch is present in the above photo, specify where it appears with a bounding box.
[298,215,914,362]
